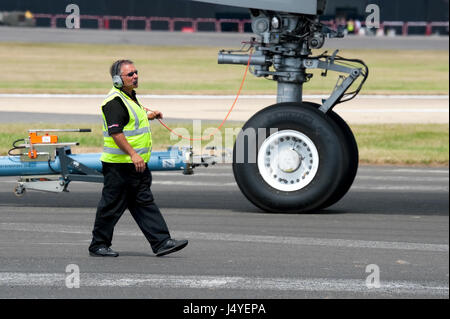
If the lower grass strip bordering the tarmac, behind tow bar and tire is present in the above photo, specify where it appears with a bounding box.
[0,122,449,166]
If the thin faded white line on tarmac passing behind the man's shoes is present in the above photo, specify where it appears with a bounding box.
[0,223,449,253]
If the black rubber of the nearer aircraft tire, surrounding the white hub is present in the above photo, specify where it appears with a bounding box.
[233,103,344,213]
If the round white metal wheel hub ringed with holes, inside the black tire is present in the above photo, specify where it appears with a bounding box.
[258,130,319,192]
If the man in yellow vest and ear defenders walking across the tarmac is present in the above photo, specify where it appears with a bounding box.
[89,60,188,257]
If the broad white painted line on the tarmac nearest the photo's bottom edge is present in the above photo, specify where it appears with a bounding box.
[0,272,449,296]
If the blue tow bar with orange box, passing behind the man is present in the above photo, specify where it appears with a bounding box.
[0,129,215,196]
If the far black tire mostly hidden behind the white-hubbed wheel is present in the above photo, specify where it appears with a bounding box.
[303,102,359,209]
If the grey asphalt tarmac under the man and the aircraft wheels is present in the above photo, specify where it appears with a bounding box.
[0,165,449,300]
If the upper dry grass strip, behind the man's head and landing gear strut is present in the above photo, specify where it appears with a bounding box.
[0,43,449,94]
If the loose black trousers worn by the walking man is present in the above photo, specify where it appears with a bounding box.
[89,163,170,252]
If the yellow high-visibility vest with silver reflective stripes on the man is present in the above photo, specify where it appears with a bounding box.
[100,88,152,163]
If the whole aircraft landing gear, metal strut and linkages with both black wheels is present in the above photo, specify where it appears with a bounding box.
[213,7,369,213]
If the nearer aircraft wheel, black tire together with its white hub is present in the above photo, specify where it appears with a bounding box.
[233,103,345,213]
